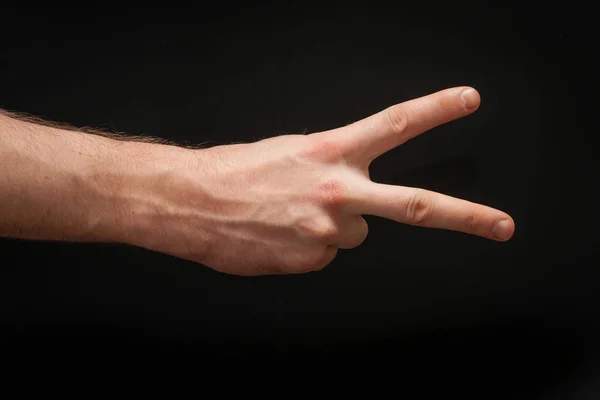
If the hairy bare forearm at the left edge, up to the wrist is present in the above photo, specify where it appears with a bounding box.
[0,112,192,243]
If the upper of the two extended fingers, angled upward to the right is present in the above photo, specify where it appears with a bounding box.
[321,86,481,161]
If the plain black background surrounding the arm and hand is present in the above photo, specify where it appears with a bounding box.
[0,2,600,398]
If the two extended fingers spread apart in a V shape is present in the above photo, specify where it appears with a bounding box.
[315,87,514,241]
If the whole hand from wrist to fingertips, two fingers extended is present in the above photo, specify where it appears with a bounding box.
[134,87,514,275]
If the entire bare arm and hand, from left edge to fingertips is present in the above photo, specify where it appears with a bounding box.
[0,87,515,276]
